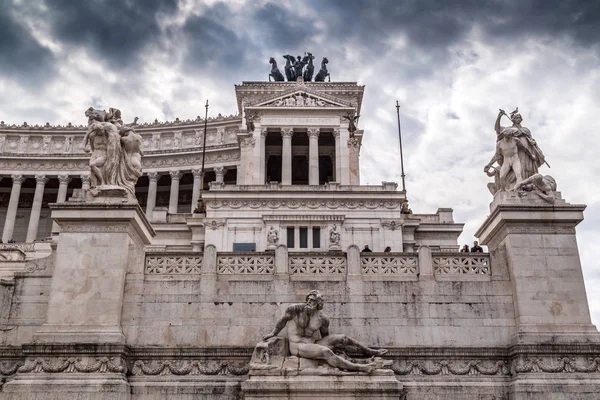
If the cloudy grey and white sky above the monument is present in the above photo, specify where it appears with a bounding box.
[0,0,600,324]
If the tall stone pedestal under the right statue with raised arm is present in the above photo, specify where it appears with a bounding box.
[476,192,600,344]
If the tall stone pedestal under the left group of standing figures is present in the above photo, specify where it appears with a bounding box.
[34,187,154,344]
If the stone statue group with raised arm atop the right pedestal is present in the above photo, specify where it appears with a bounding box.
[483,108,548,194]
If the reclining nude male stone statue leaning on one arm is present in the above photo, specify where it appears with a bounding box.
[263,290,391,373]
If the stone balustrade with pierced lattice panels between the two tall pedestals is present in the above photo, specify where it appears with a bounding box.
[144,245,492,281]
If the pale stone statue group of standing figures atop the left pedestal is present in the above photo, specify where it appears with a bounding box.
[83,107,143,199]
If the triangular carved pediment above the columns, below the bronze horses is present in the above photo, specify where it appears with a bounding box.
[248,88,354,109]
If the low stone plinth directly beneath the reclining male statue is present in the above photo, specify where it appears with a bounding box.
[242,371,405,400]
